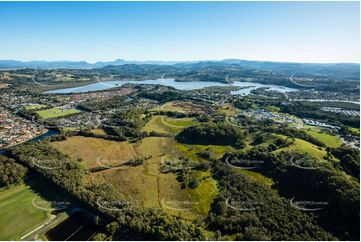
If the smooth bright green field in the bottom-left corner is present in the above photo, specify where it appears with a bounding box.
[0,185,50,240]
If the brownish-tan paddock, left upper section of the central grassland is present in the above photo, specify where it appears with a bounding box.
[52,136,137,168]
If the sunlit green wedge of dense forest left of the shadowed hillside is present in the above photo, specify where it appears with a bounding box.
[207,161,336,241]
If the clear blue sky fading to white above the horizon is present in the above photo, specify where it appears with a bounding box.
[0,2,360,62]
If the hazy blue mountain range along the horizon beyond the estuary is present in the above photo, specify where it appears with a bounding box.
[0,59,360,79]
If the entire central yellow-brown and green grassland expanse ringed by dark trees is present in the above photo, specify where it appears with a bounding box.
[53,136,218,220]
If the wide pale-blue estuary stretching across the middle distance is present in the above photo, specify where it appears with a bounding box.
[44,79,297,95]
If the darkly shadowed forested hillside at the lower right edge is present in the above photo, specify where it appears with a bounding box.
[223,147,360,240]
